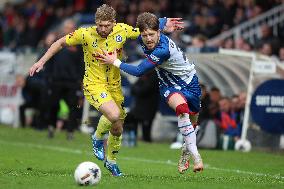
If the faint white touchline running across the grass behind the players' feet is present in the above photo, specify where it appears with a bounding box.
[0,140,284,179]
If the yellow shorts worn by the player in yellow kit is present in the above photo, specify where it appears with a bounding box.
[84,85,126,119]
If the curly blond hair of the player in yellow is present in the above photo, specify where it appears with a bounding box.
[95,4,116,22]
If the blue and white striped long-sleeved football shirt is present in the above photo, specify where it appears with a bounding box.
[120,33,196,90]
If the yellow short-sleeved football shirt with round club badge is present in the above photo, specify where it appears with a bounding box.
[66,23,140,87]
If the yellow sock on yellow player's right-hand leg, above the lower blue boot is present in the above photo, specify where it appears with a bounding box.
[107,132,122,161]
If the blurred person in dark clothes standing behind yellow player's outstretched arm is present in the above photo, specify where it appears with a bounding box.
[45,20,84,139]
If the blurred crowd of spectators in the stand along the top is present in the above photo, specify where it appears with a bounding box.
[0,0,284,60]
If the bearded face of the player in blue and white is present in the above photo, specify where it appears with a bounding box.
[141,29,160,50]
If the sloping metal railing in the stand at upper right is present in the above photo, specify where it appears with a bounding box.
[207,3,284,46]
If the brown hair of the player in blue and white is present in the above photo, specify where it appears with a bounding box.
[136,12,159,32]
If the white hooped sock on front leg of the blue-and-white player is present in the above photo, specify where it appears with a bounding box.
[178,114,199,156]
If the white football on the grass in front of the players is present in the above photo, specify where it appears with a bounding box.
[74,161,102,185]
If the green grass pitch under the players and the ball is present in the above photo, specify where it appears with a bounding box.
[0,126,284,189]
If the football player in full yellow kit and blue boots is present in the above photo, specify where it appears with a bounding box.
[30,4,183,176]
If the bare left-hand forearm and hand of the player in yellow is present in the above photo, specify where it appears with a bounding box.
[30,36,66,76]
